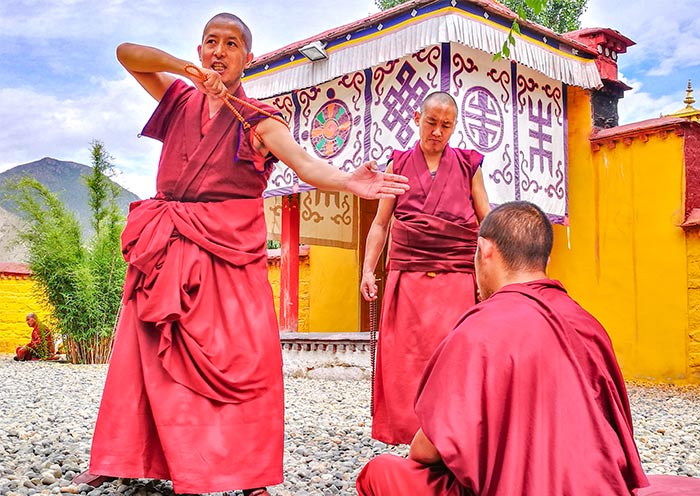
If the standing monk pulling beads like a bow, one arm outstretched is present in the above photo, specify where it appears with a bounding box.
[74,14,408,495]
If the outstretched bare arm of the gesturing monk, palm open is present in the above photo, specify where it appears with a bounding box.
[256,119,408,199]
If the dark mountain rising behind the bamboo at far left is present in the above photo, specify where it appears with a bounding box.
[0,157,139,261]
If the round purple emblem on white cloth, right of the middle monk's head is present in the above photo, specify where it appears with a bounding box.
[462,86,505,152]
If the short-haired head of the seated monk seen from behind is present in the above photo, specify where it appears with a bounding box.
[479,201,554,272]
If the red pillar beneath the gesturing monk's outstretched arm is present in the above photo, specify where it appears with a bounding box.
[280,195,299,332]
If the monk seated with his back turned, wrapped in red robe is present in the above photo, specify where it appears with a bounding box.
[357,202,648,496]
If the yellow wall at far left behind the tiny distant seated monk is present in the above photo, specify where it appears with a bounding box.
[0,275,50,354]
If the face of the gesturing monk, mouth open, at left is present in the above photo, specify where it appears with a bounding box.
[197,18,253,91]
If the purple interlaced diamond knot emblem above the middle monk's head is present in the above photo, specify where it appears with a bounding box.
[382,62,430,147]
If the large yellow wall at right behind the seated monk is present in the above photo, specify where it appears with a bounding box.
[549,88,688,382]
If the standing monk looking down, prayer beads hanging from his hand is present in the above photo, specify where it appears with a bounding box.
[360,92,489,444]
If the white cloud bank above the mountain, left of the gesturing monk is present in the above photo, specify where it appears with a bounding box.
[0,77,160,196]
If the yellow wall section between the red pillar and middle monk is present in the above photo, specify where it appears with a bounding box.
[309,246,360,332]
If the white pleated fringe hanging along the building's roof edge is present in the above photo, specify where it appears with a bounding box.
[244,2,602,98]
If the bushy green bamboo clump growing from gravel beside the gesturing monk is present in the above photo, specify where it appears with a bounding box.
[8,141,126,363]
